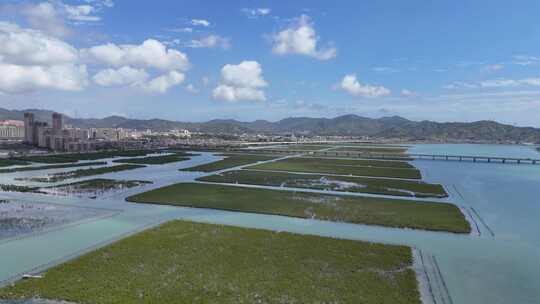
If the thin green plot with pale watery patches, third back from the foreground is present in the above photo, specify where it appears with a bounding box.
[198,170,448,197]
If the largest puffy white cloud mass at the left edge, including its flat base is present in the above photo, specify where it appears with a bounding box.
[0,22,88,93]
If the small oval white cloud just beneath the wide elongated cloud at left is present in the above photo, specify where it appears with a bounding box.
[93,66,148,87]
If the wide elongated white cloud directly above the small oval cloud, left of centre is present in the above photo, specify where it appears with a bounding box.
[82,39,190,71]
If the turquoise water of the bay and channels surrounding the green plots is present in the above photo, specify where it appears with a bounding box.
[0,145,540,303]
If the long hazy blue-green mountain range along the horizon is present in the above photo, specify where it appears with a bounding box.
[0,108,540,143]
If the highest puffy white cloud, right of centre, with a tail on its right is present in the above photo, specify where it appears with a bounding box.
[272,15,337,60]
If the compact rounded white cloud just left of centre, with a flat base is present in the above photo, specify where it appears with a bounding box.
[212,61,268,102]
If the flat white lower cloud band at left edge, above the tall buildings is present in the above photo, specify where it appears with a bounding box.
[0,63,88,93]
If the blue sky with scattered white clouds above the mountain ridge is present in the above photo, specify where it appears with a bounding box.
[0,0,540,127]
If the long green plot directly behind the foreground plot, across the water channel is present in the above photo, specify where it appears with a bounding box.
[126,183,470,233]
